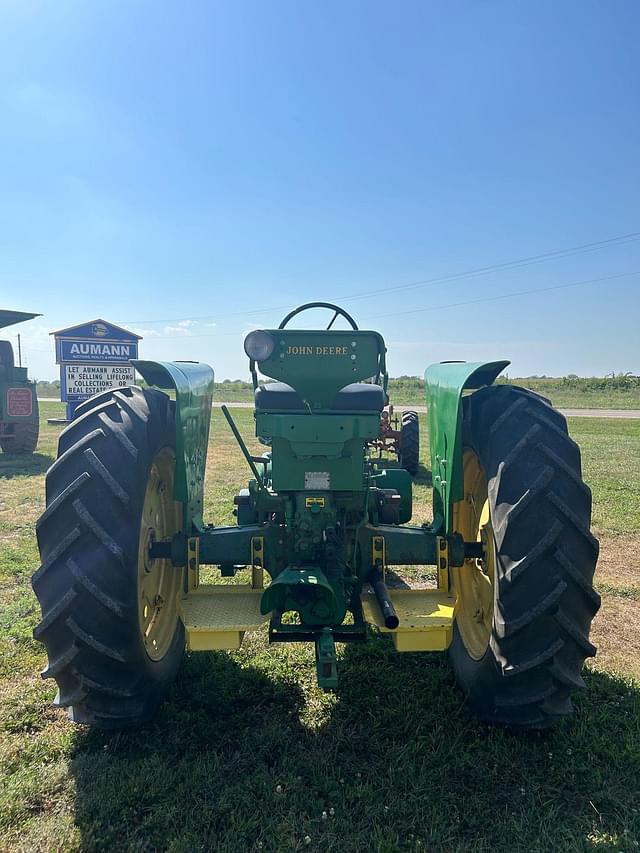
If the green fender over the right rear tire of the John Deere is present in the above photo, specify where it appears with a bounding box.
[424,361,511,535]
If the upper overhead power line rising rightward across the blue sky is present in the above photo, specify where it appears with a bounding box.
[120,226,640,326]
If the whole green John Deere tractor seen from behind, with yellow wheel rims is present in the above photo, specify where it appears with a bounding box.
[33,303,600,729]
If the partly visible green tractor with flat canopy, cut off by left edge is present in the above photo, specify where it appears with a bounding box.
[0,309,40,455]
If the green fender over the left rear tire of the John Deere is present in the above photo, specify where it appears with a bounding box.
[132,360,213,534]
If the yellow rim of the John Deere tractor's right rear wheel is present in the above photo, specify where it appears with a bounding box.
[452,448,496,660]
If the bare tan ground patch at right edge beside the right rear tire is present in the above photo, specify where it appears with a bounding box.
[589,595,640,678]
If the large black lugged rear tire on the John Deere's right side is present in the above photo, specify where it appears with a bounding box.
[450,385,600,729]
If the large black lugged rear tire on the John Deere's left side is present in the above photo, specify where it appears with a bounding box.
[32,387,184,728]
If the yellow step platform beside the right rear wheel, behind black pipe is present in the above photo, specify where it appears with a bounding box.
[362,589,455,652]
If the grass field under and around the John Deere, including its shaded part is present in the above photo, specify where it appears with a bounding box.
[0,404,640,853]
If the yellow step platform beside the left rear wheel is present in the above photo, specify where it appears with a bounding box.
[180,584,269,652]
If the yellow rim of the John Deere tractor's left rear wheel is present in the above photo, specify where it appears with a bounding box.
[138,447,182,660]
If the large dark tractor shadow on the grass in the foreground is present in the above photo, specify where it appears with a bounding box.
[71,638,640,853]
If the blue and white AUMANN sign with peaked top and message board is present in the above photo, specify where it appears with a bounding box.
[51,319,141,421]
